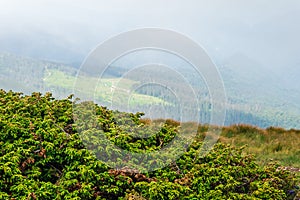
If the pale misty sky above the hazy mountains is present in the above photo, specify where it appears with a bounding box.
[0,0,300,71]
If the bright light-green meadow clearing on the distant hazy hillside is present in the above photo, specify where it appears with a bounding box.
[43,69,168,105]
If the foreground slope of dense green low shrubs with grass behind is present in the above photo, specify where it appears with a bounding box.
[0,90,299,200]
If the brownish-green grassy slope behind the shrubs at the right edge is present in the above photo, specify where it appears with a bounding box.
[220,125,300,168]
